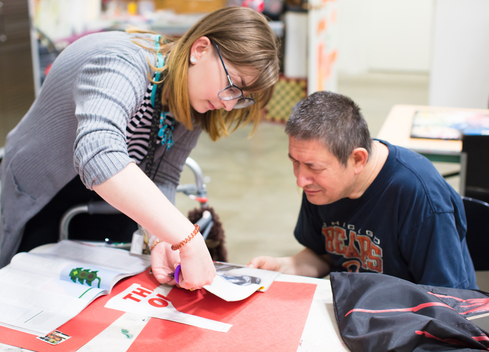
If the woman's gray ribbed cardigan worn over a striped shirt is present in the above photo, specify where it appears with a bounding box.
[0,32,201,267]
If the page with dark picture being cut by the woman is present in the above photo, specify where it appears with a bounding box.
[204,262,280,302]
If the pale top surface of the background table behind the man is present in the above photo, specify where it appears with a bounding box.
[377,105,489,154]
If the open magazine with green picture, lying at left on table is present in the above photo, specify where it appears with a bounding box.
[0,240,151,335]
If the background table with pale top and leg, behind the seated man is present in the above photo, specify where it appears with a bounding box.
[377,105,489,195]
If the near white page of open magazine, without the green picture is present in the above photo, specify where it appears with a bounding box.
[0,266,107,335]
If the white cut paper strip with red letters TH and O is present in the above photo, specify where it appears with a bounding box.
[105,284,232,332]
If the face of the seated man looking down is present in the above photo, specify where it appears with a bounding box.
[289,137,357,205]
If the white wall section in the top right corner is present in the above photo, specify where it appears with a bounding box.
[429,0,489,109]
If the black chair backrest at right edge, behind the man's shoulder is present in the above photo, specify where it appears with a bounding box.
[462,135,489,203]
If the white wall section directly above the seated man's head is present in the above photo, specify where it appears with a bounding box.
[338,0,434,74]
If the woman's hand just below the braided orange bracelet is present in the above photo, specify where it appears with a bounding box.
[174,235,216,290]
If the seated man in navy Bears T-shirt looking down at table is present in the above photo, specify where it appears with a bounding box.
[248,92,477,289]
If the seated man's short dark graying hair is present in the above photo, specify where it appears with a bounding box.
[285,91,372,165]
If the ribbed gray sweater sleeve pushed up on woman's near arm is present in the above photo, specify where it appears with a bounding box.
[74,51,149,189]
